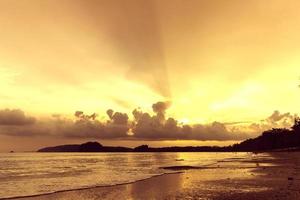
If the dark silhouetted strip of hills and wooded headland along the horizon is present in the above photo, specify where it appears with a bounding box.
[38,118,300,152]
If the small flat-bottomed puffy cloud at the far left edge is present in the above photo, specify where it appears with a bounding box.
[0,109,35,126]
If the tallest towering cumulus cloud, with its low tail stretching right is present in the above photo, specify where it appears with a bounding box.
[132,102,249,140]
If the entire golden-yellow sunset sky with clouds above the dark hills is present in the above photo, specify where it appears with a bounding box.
[0,0,300,151]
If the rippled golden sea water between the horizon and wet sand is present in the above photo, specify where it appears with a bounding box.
[0,153,250,199]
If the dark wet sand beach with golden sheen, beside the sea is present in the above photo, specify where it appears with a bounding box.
[10,152,300,200]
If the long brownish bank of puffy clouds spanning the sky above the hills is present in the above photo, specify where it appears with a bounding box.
[0,102,297,141]
